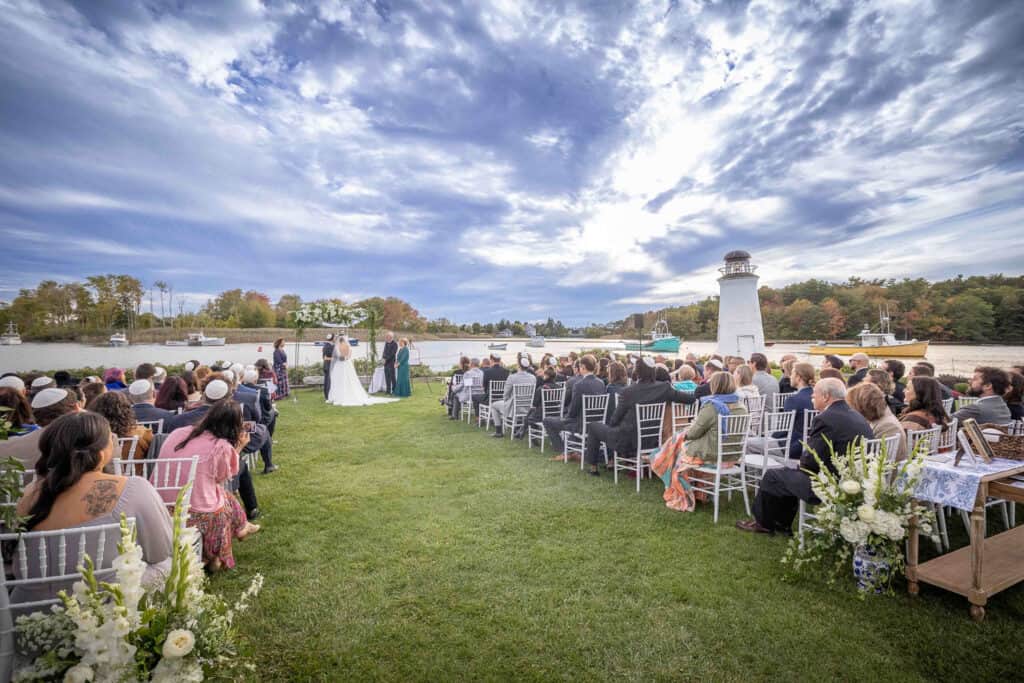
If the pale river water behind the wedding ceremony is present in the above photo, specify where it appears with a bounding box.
[0,339,1024,376]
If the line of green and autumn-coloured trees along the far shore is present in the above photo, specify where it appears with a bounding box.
[0,274,1024,342]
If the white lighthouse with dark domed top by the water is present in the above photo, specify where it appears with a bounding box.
[718,251,765,359]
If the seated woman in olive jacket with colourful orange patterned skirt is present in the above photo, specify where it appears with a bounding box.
[650,372,746,512]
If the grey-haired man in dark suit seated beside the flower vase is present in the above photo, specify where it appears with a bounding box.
[736,378,874,535]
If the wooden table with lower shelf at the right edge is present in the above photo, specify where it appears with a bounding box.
[906,463,1024,622]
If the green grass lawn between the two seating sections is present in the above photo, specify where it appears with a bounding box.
[213,385,1024,681]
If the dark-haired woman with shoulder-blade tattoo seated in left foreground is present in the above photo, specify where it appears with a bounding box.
[13,413,172,602]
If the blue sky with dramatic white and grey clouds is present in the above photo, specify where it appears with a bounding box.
[0,0,1024,323]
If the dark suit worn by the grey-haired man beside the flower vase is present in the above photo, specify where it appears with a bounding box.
[754,400,874,532]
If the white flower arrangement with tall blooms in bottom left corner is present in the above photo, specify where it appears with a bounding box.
[13,489,263,683]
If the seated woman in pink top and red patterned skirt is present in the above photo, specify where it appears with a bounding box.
[160,398,259,571]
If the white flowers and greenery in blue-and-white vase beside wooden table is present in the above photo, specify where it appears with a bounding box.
[782,442,935,595]
